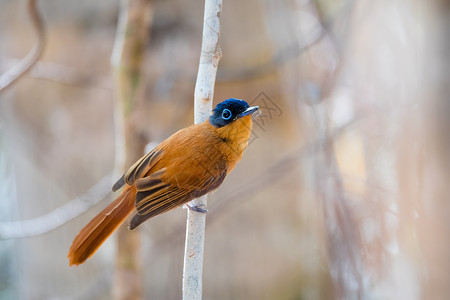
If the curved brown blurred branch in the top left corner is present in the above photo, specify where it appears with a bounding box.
[0,0,45,94]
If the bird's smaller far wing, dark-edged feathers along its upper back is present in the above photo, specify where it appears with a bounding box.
[112,149,163,192]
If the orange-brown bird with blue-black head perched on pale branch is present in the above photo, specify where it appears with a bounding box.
[67,98,259,266]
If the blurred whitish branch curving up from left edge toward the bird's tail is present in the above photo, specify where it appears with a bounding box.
[0,174,112,239]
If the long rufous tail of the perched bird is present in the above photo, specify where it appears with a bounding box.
[67,187,136,266]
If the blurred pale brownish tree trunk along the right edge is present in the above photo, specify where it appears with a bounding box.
[416,0,450,299]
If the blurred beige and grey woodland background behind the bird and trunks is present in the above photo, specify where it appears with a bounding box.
[0,0,450,299]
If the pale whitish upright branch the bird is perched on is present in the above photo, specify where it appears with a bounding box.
[183,0,222,300]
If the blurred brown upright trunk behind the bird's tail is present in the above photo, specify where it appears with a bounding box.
[111,0,153,299]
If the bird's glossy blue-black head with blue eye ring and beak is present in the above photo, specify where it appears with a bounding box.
[209,98,259,128]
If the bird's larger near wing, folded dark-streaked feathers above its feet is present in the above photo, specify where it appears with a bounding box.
[129,168,227,229]
